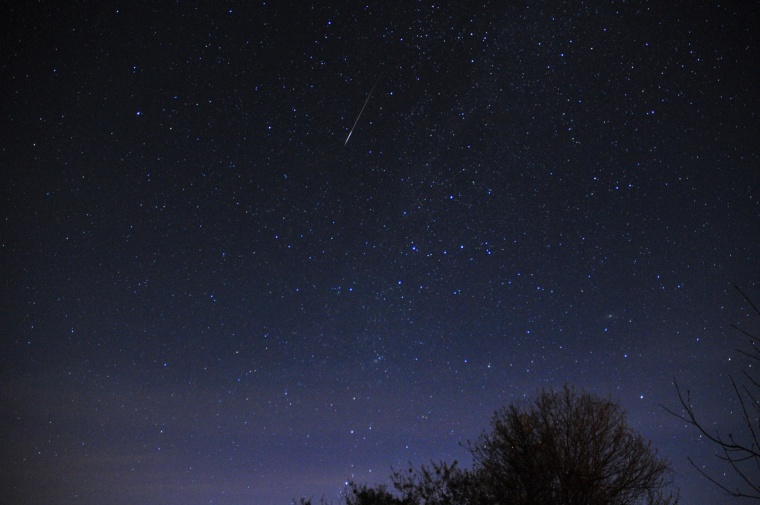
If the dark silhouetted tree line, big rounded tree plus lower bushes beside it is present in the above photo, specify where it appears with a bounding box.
[298,386,678,505]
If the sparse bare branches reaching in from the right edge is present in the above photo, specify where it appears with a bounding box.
[663,286,760,500]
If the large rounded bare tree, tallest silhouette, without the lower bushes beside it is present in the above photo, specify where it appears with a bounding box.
[470,386,678,505]
